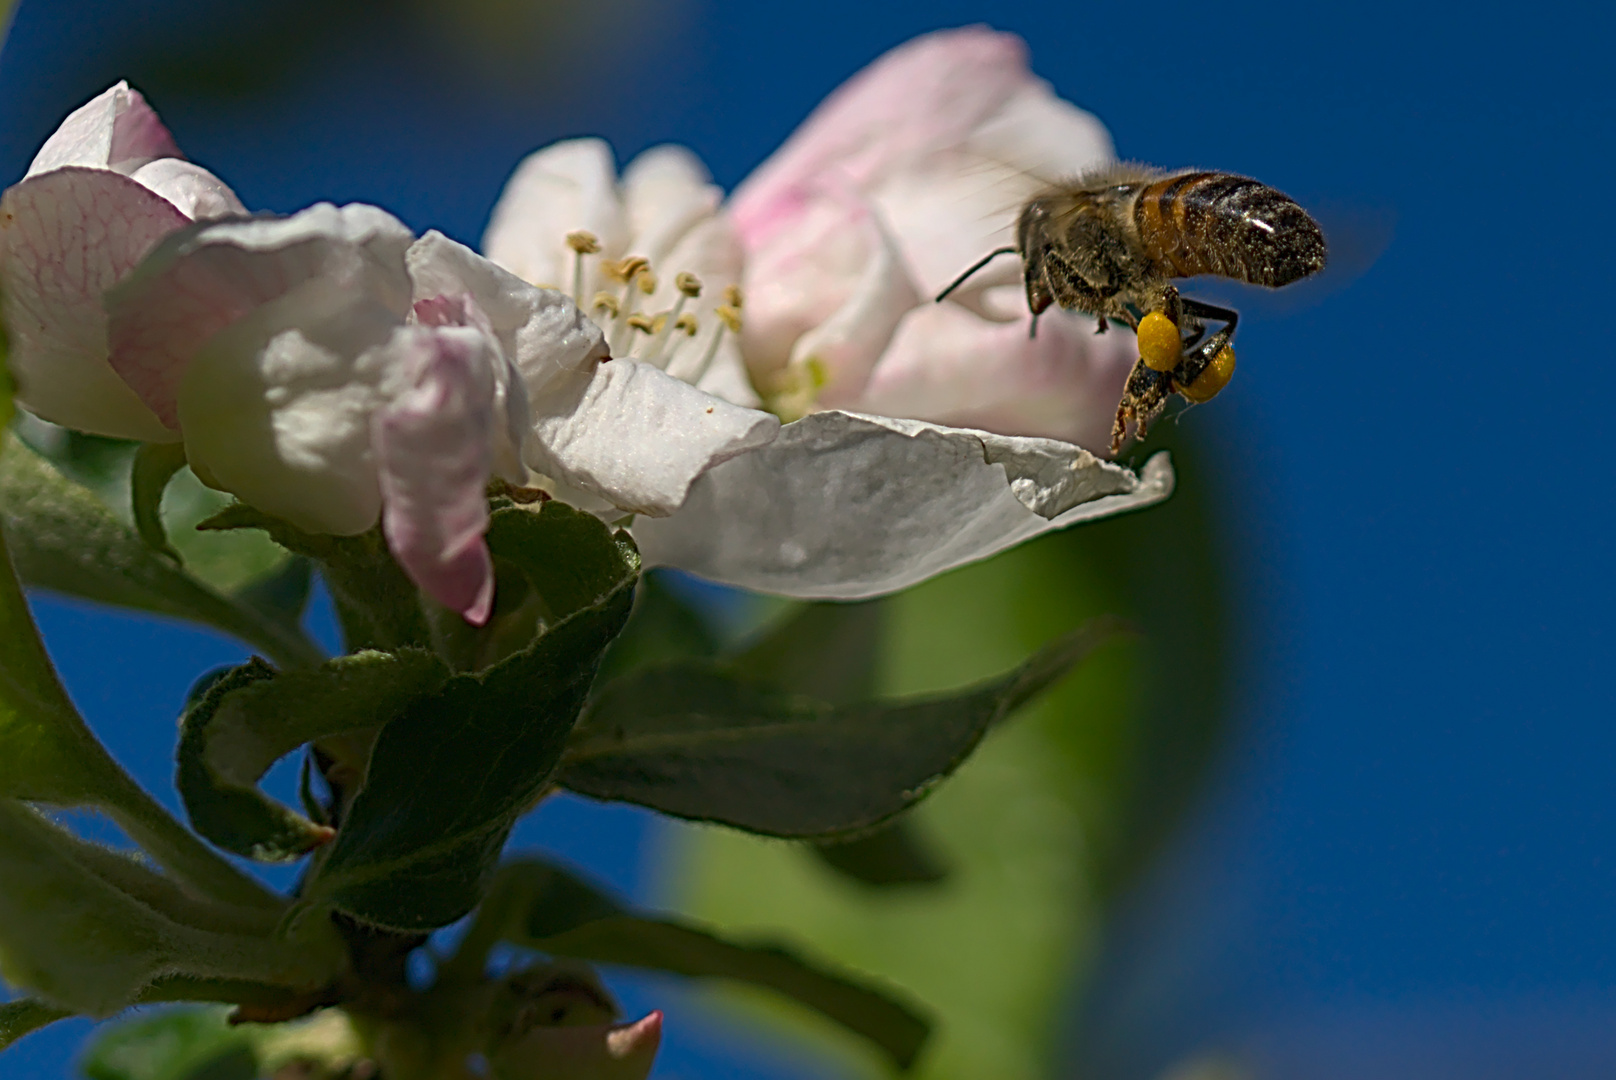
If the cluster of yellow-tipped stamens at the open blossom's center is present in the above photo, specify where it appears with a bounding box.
[567,230,742,385]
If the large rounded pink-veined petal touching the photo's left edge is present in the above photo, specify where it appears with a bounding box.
[0,167,187,441]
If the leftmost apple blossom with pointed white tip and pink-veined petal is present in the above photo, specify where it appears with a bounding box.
[0,82,244,441]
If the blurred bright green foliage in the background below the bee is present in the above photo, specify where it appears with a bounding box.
[669,430,1228,1080]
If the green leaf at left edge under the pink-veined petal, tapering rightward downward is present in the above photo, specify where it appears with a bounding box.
[0,437,322,666]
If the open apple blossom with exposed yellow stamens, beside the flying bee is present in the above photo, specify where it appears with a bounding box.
[483,29,1172,598]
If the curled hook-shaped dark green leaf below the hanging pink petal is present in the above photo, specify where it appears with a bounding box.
[178,650,449,862]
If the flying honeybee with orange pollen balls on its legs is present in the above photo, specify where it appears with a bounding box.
[937,163,1325,454]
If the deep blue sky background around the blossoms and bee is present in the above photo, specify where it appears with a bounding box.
[0,0,1616,1080]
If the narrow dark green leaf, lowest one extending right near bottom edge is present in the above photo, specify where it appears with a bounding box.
[462,860,931,1069]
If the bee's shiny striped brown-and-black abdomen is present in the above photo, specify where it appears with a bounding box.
[1133,173,1325,288]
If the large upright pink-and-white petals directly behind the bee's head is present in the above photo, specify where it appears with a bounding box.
[729,27,1134,448]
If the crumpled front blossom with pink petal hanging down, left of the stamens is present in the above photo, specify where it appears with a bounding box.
[107,205,779,622]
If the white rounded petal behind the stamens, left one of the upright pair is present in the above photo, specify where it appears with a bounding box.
[483,139,629,292]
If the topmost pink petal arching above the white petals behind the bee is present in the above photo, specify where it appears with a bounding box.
[730,26,1031,249]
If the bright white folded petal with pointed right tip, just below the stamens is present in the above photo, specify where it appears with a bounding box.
[524,359,781,516]
